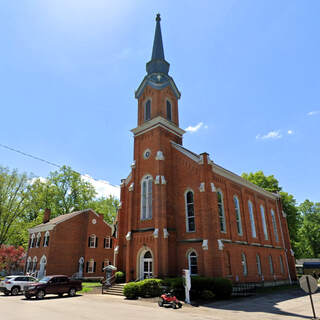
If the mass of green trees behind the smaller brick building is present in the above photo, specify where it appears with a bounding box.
[0,166,119,248]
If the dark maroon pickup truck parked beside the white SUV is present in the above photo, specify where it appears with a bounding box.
[24,275,82,299]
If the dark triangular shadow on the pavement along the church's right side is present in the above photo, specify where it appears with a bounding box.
[203,289,312,319]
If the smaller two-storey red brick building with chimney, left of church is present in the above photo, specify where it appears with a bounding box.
[26,209,114,278]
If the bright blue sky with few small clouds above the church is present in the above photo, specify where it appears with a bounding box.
[0,0,320,202]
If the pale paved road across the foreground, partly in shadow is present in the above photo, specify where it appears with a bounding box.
[0,289,320,320]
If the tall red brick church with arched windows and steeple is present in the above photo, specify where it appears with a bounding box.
[114,15,296,282]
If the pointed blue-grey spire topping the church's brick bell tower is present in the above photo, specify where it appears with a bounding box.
[146,13,170,74]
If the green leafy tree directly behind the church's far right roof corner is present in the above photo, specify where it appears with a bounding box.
[241,171,303,257]
